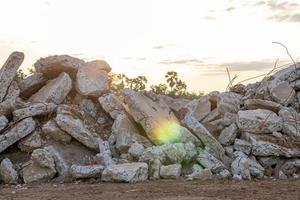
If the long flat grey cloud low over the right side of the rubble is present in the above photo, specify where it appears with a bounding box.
[220,60,274,71]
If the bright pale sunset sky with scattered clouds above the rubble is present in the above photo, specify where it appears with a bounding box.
[0,0,300,93]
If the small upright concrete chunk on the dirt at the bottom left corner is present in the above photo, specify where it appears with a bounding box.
[0,158,18,184]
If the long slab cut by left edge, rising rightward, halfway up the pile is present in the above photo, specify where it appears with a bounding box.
[0,118,36,152]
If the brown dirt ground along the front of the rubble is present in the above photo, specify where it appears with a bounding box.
[0,179,300,200]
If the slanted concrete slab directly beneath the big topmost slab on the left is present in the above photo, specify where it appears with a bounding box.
[29,72,72,104]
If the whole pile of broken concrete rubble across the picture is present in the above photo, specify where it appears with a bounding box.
[0,52,300,184]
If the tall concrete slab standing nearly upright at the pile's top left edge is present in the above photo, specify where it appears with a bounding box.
[0,52,24,102]
